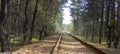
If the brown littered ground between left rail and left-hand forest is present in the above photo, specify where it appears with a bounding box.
[12,35,58,54]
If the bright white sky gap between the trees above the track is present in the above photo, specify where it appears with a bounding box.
[63,0,72,24]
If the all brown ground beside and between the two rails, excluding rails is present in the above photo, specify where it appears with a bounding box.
[12,34,120,54]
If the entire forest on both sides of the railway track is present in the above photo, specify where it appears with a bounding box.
[0,0,120,52]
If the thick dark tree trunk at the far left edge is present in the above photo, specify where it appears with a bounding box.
[0,0,10,52]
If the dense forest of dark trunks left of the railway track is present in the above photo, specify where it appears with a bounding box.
[0,0,63,52]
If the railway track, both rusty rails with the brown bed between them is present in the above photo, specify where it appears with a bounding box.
[50,33,107,54]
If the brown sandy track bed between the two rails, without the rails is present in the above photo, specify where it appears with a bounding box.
[59,35,96,54]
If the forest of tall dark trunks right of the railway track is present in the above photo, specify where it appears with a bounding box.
[71,0,120,48]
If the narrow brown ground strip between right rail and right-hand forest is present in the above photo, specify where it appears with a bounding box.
[76,35,120,54]
